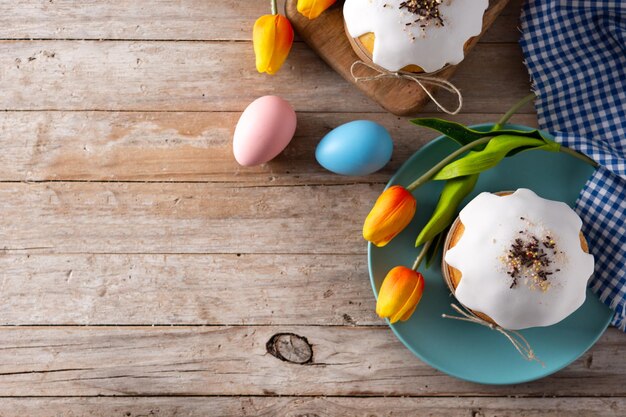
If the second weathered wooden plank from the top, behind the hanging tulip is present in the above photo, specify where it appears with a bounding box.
[0,41,530,113]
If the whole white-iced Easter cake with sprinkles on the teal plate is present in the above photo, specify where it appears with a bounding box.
[442,189,594,330]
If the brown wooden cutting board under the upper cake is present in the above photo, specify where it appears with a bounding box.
[285,0,509,116]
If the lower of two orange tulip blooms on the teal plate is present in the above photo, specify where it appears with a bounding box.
[376,266,424,323]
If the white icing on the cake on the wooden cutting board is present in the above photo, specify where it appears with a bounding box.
[343,0,489,72]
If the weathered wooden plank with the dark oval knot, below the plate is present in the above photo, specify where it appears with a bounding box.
[0,326,626,397]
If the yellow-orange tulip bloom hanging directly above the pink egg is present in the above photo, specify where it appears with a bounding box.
[252,14,293,74]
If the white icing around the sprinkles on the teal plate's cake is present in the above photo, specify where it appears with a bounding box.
[445,188,594,330]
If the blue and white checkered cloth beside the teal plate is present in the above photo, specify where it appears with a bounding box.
[520,0,626,331]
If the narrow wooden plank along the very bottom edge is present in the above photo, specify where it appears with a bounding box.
[0,397,626,417]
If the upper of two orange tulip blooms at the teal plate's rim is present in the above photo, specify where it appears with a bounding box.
[363,185,417,246]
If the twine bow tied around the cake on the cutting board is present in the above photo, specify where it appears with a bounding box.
[350,60,463,115]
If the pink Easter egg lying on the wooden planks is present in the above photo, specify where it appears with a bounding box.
[233,96,296,166]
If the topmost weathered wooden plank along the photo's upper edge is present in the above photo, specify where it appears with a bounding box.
[0,0,521,42]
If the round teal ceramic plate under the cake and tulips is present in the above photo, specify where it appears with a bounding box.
[368,125,611,384]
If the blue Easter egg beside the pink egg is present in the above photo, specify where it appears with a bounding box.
[315,120,393,175]
